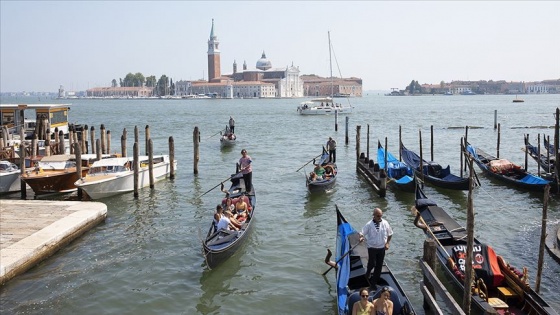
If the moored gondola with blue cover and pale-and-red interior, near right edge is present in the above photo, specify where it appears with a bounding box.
[465,142,550,191]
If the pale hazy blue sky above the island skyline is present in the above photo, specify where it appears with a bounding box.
[0,0,560,92]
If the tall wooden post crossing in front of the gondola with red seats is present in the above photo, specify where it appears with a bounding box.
[463,159,474,314]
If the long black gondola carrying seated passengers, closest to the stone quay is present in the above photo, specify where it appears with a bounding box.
[202,170,257,268]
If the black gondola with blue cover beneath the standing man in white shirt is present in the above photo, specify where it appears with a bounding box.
[325,206,415,315]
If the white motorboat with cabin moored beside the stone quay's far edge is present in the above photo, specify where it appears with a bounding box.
[74,155,177,199]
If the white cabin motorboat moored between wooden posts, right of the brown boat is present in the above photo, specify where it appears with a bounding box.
[76,160,177,199]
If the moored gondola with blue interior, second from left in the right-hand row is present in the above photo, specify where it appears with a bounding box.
[400,143,469,190]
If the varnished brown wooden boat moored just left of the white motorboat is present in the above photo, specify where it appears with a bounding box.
[21,167,89,195]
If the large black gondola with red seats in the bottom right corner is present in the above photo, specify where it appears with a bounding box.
[415,187,557,315]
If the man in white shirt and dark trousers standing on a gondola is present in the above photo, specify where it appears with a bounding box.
[360,208,393,290]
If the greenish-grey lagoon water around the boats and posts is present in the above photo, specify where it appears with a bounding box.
[0,93,560,314]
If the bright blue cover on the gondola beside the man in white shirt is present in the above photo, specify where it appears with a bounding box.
[336,222,357,315]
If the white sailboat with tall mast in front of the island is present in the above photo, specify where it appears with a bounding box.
[297,32,352,115]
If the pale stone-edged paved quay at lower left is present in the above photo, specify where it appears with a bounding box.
[0,199,107,285]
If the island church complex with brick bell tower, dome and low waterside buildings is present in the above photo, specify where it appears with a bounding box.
[83,19,362,98]
